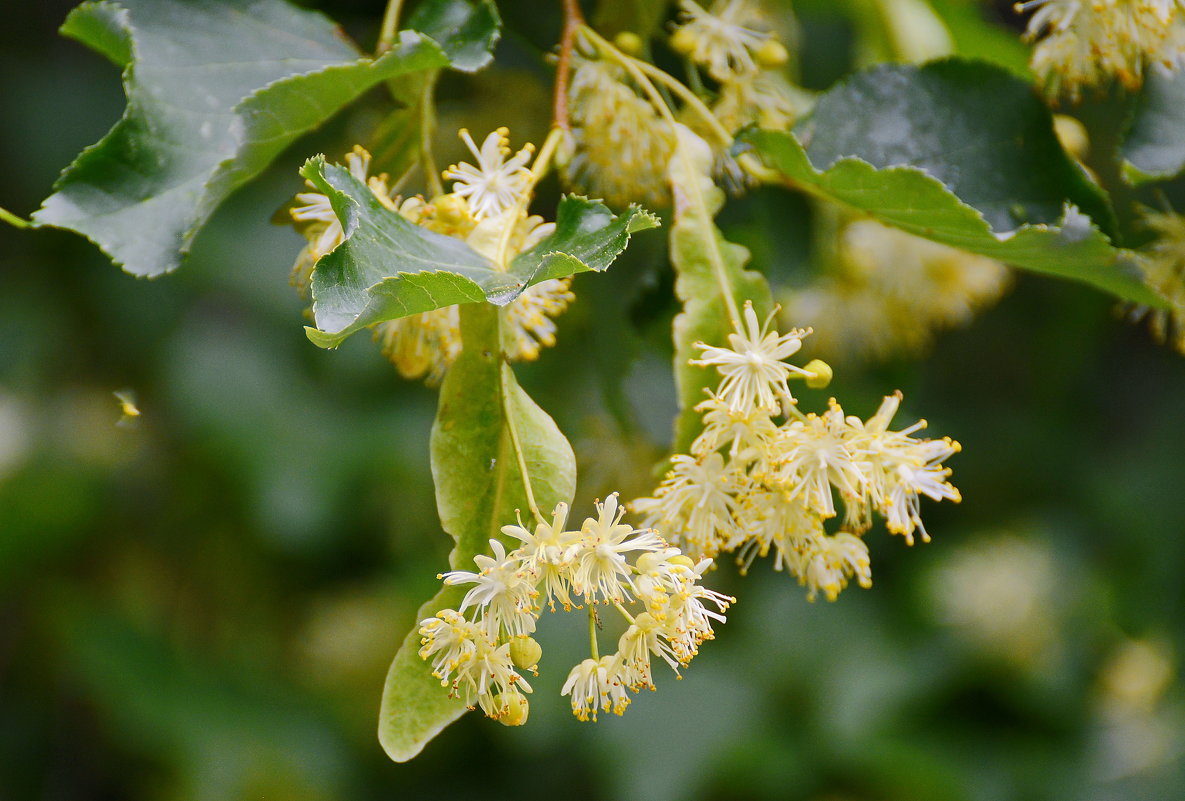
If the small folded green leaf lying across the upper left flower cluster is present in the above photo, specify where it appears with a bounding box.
[301,156,656,347]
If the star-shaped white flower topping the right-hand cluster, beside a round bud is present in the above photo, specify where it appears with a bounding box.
[691,301,813,411]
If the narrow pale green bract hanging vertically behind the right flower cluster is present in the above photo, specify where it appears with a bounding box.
[671,128,773,454]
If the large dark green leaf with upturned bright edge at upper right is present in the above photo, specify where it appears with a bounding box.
[741,60,1164,307]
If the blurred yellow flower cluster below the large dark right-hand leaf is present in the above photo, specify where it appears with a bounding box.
[786,219,1011,358]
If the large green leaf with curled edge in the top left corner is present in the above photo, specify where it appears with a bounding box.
[34,0,448,276]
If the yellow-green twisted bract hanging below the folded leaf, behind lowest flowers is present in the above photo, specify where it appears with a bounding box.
[379,303,576,762]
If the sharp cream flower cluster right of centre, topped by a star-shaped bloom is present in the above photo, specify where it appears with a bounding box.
[632,303,959,600]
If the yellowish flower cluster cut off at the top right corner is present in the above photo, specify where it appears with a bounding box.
[1016,0,1185,97]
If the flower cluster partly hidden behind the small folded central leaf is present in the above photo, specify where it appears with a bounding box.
[290,128,575,384]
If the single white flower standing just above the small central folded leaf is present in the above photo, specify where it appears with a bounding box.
[444,128,534,220]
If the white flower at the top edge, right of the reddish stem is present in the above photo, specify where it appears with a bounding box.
[671,0,769,82]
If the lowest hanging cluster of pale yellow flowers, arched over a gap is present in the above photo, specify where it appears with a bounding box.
[419,493,734,725]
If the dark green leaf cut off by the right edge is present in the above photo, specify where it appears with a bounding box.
[1120,68,1185,184]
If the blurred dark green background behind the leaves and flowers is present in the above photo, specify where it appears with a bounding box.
[0,0,1185,801]
